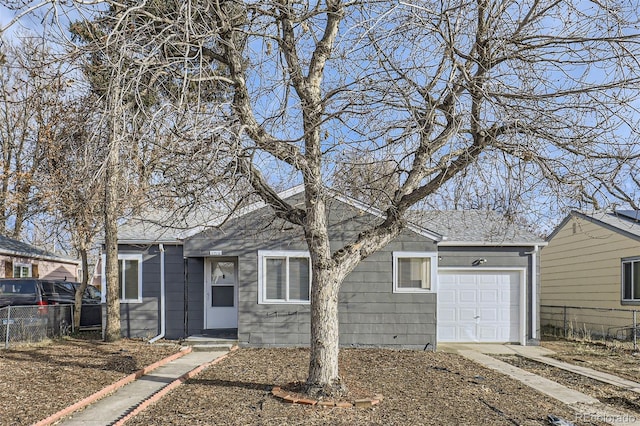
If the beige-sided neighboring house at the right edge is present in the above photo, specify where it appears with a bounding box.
[540,210,640,339]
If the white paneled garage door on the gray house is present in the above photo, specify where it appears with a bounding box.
[437,269,522,343]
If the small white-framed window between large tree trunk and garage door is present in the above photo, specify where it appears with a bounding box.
[393,252,438,293]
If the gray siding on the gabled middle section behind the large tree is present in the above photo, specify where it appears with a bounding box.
[185,201,436,348]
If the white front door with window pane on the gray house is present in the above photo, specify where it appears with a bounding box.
[204,257,238,329]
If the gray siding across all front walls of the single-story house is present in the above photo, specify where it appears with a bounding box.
[120,195,539,349]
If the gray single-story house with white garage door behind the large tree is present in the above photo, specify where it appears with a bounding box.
[103,187,545,349]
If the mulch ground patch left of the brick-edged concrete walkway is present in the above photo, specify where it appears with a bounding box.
[0,338,180,425]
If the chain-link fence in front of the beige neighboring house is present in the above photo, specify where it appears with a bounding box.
[540,305,640,351]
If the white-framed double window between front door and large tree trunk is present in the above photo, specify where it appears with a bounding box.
[258,251,311,304]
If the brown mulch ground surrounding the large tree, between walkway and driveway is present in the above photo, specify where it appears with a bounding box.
[128,349,594,425]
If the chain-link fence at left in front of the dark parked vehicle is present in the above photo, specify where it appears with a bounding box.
[0,305,75,349]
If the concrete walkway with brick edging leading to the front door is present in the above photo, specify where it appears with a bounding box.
[57,350,228,426]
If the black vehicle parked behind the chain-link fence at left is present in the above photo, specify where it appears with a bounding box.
[0,278,102,328]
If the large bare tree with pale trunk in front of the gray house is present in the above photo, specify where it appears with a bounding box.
[5,0,640,394]
